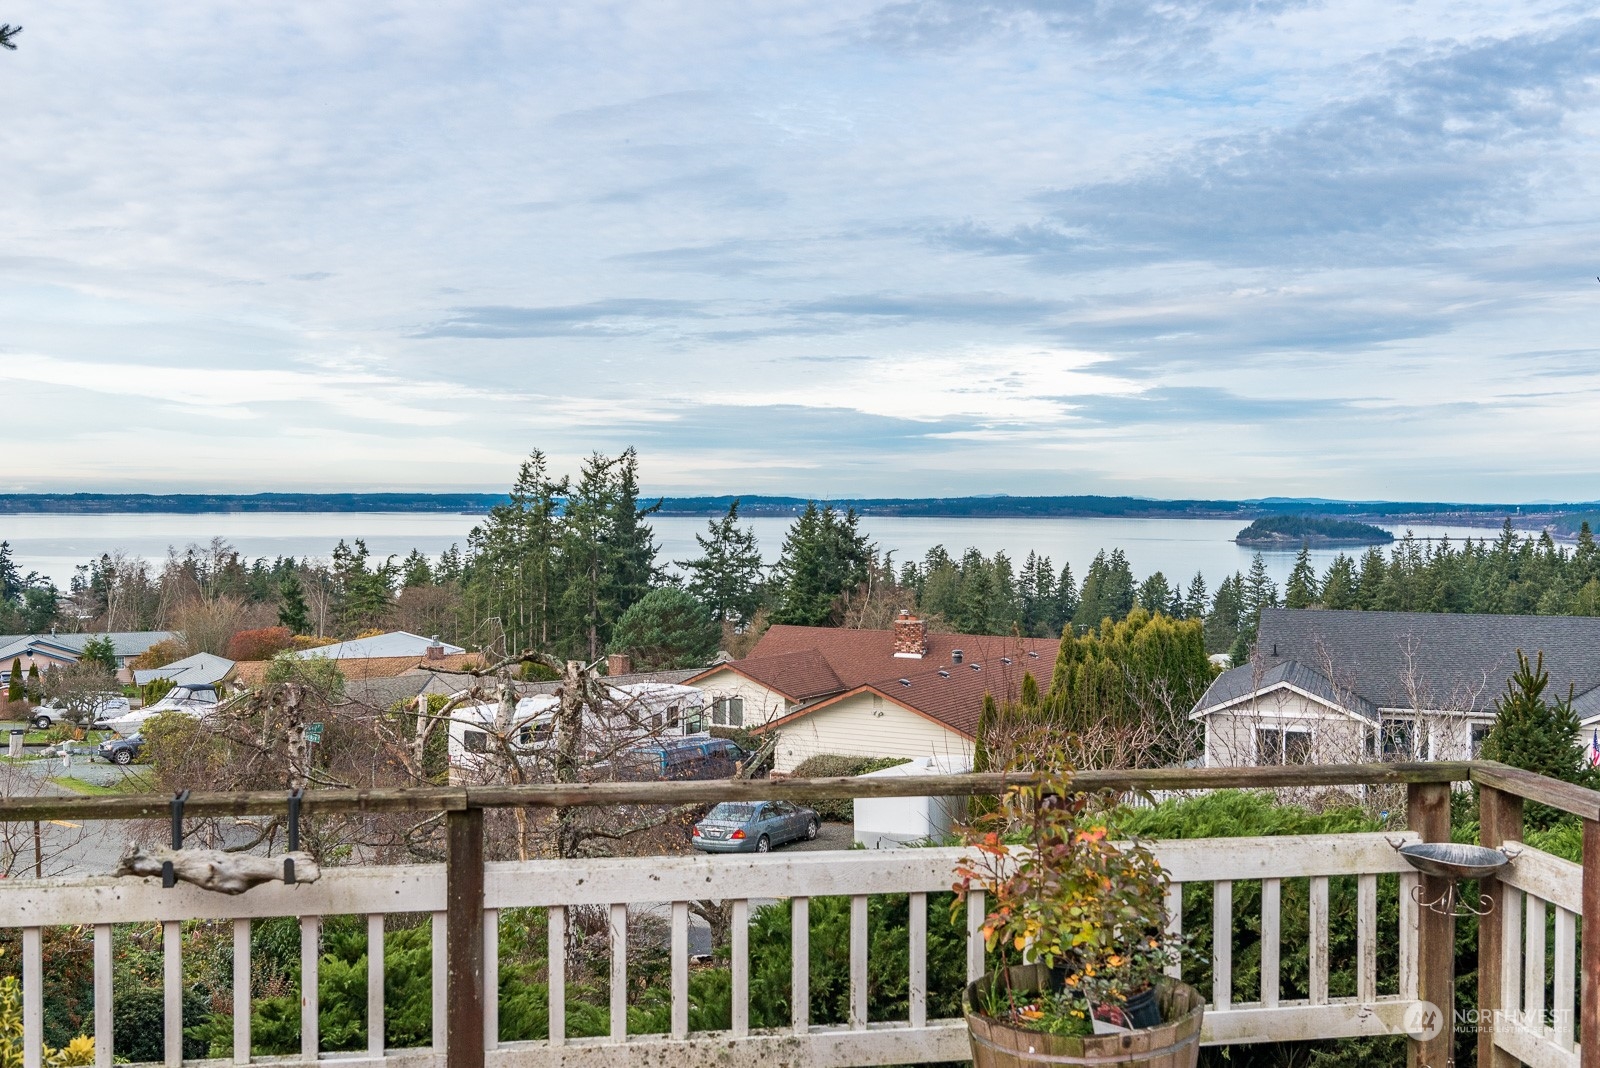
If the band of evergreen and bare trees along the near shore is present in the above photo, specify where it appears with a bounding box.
[9,449,1600,667]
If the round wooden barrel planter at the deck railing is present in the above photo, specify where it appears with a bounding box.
[962,964,1205,1068]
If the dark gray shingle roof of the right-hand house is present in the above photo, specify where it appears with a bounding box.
[1195,608,1600,716]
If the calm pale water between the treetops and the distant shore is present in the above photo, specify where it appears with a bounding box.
[0,512,1542,590]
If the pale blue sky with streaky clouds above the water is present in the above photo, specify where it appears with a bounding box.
[0,0,1600,502]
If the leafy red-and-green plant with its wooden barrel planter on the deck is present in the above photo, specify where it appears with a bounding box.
[955,758,1205,1068]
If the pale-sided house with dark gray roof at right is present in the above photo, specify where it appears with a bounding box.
[1190,608,1600,766]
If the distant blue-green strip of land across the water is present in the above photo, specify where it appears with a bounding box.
[0,492,1580,527]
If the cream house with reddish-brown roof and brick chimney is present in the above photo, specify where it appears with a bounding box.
[688,612,1061,772]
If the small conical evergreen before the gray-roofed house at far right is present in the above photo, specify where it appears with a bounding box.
[1483,649,1590,825]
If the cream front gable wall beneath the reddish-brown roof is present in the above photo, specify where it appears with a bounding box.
[774,694,973,772]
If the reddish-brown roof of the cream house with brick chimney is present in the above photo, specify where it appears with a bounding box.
[720,627,1061,737]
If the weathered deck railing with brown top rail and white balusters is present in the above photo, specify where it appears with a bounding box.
[0,763,1600,1068]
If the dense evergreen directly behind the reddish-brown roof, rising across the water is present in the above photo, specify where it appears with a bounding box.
[773,500,872,627]
